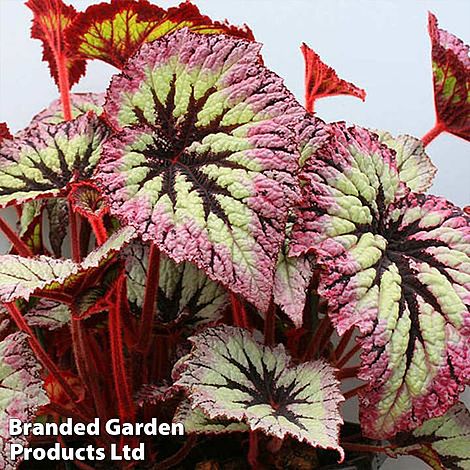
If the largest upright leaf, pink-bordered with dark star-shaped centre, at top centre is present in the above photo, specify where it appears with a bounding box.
[98,30,304,309]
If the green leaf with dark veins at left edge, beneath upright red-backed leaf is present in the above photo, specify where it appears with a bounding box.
[0,114,108,207]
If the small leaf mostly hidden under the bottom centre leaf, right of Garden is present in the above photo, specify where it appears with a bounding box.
[173,400,250,434]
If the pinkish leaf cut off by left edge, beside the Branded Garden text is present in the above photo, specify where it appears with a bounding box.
[0,332,49,470]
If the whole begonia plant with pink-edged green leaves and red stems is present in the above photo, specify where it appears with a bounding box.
[0,0,470,470]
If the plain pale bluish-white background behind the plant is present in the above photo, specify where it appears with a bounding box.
[0,0,470,470]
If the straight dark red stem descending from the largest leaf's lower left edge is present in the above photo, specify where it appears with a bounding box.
[137,243,160,352]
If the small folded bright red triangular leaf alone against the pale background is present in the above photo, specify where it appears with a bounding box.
[300,43,366,113]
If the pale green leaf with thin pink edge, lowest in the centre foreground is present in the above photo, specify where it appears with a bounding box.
[175,326,343,456]
